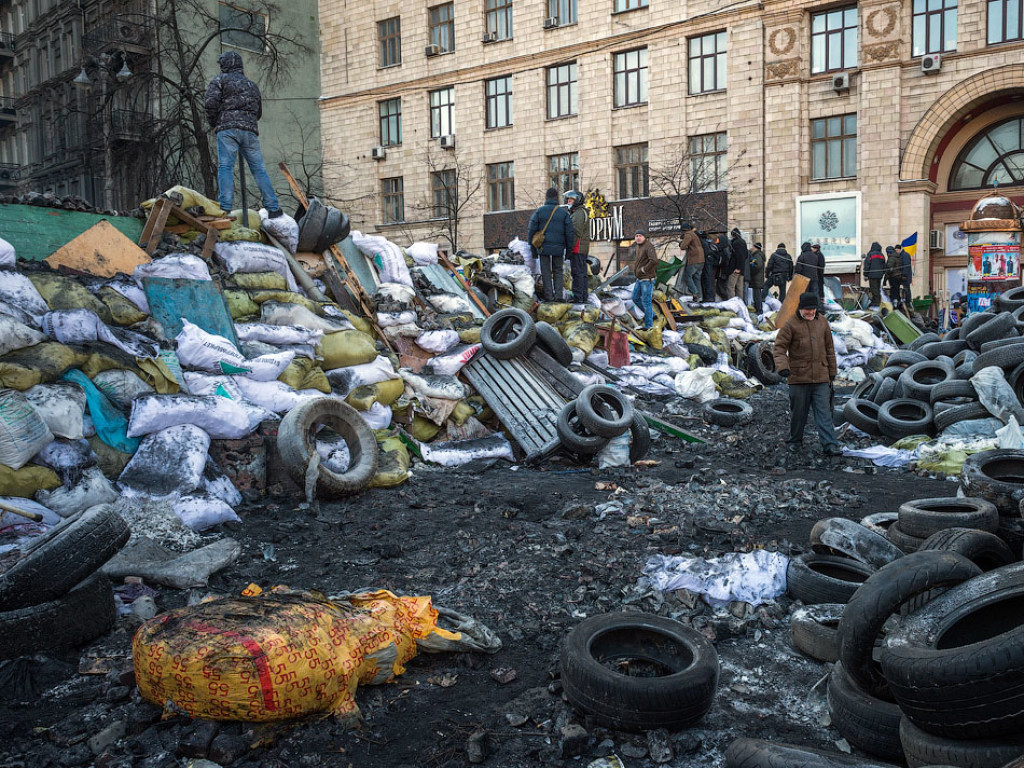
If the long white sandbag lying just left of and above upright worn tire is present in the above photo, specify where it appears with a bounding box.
[128,394,259,439]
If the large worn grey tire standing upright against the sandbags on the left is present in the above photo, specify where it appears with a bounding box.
[278,397,377,498]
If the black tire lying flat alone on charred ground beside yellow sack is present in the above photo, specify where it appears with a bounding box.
[561,613,719,731]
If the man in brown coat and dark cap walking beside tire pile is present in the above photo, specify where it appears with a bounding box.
[775,292,843,456]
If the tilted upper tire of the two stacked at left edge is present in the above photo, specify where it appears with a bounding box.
[0,504,131,610]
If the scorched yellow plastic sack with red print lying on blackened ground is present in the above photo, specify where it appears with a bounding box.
[132,588,501,722]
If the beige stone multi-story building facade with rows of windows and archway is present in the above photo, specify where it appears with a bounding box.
[321,0,1024,301]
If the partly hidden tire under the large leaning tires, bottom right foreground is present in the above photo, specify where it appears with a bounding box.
[826,664,903,763]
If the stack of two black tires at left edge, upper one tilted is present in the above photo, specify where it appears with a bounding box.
[0,504,130,659]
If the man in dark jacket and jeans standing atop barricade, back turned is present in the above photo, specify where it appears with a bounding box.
[203,50,282,218]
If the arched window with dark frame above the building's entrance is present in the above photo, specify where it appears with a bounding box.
[949,117,1024,189]
